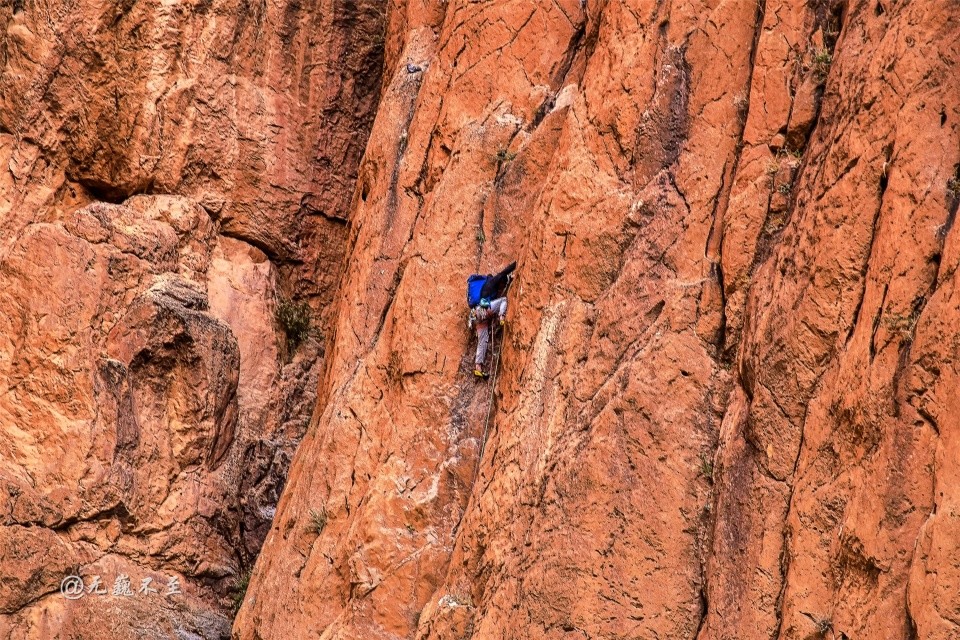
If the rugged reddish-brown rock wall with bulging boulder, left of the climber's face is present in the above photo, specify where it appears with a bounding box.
[0,0,385,639]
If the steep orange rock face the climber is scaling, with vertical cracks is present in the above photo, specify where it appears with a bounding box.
[233,0,960,640]
